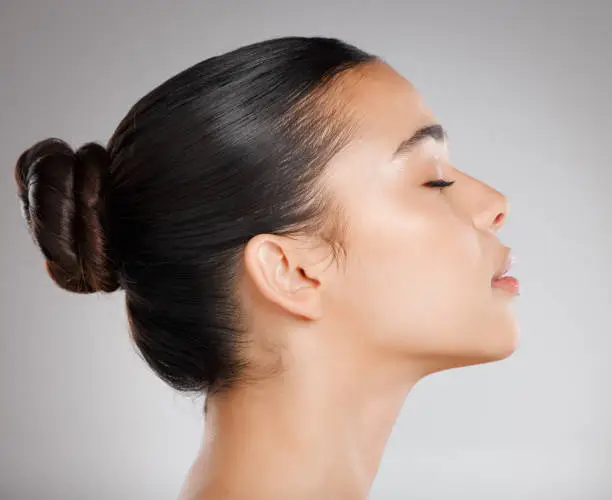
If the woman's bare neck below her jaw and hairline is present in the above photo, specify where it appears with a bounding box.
[186,328,424,500]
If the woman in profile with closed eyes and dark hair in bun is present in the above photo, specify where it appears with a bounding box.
[16,37,518,500]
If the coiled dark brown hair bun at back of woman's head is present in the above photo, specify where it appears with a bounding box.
[15,139,119,293]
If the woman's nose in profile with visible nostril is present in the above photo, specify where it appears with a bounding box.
[467,172,509,232]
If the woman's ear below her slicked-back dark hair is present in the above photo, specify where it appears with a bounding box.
[244,234,322,320]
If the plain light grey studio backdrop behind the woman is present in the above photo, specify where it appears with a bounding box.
[0,0,612,500]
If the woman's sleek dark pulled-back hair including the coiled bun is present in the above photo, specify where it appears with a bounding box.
[15,37,377,392]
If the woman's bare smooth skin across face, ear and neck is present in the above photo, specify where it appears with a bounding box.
[181,62,519,500]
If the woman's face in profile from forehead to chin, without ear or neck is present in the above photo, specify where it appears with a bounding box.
[325,63,518,368]
